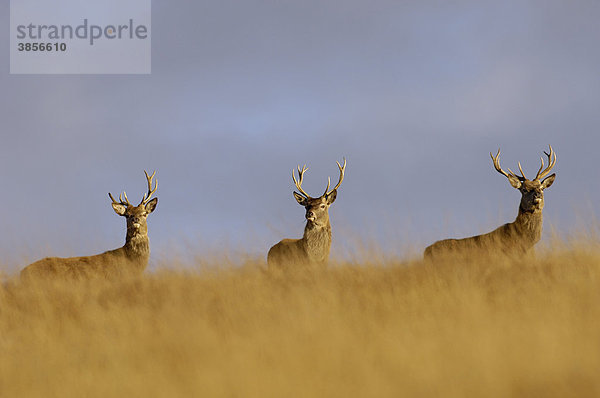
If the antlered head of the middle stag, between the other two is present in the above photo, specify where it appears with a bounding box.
[292,158,346,226]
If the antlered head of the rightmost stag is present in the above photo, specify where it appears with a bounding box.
[490,146,556,212]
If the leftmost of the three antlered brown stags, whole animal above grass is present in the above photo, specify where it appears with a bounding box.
[21,171,158,280]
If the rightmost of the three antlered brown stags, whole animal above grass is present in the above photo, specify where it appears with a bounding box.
[424,146,556,259]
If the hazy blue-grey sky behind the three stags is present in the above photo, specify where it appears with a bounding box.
[0,0,600,269]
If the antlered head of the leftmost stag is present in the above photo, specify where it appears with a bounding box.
[108,170,158,234]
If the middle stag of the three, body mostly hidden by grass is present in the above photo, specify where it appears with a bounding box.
[267,159,346,269]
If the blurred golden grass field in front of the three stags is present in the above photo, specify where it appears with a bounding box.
[0,245,600,397]
